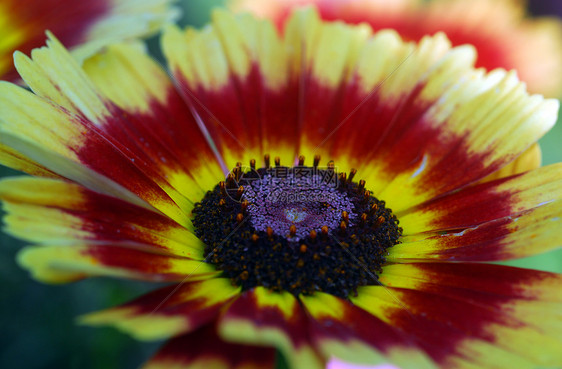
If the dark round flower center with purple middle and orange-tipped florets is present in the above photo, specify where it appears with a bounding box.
[193,155,402,298]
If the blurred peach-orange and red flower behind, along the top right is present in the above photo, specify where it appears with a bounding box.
[230,0,562,96]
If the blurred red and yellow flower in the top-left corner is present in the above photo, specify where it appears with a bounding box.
[0,0,179,81]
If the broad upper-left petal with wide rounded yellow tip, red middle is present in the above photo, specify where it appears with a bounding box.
[83,44,224,202]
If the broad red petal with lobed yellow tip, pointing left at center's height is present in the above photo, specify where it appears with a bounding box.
[0,177,216,283]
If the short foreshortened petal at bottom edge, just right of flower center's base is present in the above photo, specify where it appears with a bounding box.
[300,293,434,368]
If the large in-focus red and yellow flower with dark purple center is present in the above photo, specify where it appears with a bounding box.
[0,10,562,368]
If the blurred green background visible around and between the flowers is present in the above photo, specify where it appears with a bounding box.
[0,0,562,369]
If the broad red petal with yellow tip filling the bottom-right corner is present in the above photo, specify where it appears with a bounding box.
[352,263,562,368]
